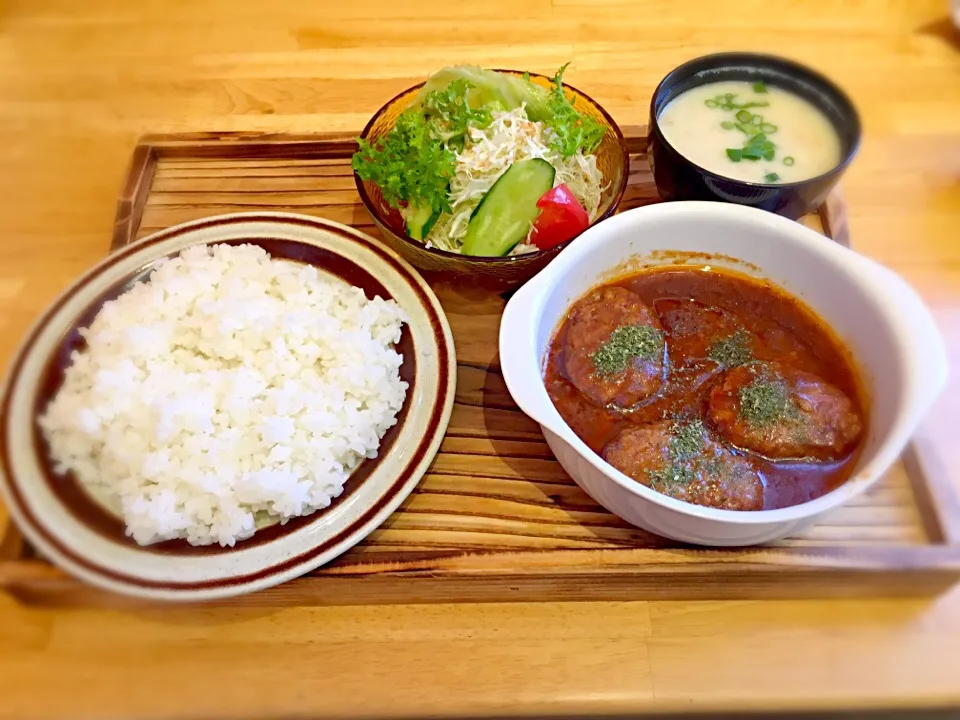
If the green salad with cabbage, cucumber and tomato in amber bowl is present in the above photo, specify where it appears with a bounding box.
[353,65,606,257]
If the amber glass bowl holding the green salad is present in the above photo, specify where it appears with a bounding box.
[354,70,630,291]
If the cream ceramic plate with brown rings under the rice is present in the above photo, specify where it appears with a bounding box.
[0,213,456,600]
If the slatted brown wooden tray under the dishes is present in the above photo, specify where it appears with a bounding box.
[0,128,960,605]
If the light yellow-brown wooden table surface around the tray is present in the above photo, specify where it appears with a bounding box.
[0,0,960,718]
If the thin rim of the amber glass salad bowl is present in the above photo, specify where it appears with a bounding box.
[353,68,630,265]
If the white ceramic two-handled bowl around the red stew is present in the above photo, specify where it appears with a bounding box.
[500,202,947,546]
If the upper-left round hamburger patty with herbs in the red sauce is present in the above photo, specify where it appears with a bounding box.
[564,287,663,408]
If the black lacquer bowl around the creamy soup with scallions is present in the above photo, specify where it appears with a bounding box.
[649,52,861,219]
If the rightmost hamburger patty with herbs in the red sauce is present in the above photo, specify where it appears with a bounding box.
[710,362,863,460]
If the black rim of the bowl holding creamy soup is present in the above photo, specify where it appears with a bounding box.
[649,52,863,191]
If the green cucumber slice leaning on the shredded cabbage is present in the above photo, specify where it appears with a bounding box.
[463,158,556,257]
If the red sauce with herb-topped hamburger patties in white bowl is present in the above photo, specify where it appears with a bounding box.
[545,265,866,510]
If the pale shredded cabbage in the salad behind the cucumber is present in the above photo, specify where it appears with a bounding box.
[426,103,604,255]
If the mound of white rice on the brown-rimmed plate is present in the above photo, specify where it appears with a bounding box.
[40,245,407,545]
